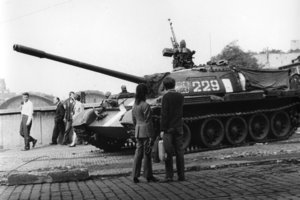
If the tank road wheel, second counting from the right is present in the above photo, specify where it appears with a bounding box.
[249,113,270,142]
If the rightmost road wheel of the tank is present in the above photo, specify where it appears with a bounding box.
[271,111,292,139]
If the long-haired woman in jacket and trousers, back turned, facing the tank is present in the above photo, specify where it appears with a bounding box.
[132,83,158,183]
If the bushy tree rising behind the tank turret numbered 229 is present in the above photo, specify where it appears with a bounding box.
[212,42,260,68]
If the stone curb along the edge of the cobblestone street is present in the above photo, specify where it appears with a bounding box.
[3,158,300,185]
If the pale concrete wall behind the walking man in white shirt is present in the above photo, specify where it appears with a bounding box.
[0,106,55,149]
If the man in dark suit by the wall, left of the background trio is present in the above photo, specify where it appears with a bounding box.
[50,97,65,145]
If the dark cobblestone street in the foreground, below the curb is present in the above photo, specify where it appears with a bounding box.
[0,163,300,200]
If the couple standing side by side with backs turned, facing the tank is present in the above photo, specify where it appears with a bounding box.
[132,77,185,183]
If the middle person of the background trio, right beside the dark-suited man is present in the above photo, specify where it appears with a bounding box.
[63,91,75,145]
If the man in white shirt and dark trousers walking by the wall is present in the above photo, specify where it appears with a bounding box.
[20,92,37,151]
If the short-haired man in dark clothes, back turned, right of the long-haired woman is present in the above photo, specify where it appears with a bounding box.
[160,77,185,182]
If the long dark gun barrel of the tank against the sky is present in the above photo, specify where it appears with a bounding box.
[13,44,146,83]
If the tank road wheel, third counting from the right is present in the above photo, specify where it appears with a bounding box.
[225,117,248,145]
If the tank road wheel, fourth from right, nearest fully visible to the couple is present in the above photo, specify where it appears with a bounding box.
[200,118,224,147]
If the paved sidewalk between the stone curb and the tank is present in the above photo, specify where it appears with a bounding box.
[0,134,300,184]
